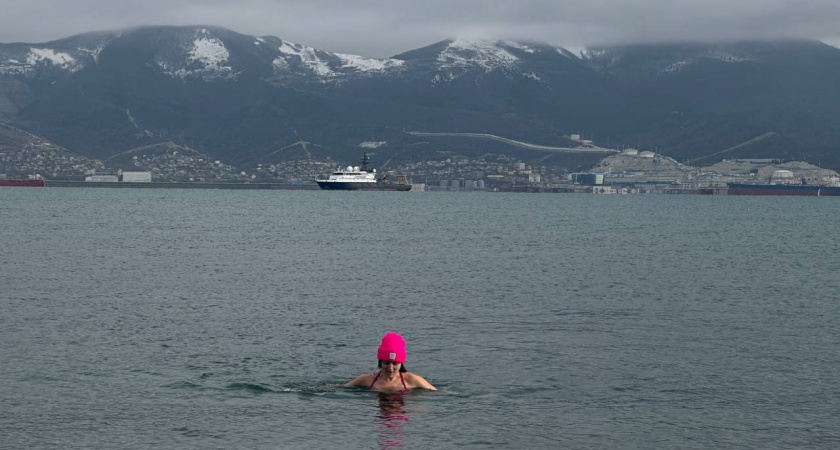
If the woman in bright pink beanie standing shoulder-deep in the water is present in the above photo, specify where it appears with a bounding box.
[345,332,437,392]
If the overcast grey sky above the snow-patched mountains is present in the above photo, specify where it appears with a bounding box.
[0,0,840,57]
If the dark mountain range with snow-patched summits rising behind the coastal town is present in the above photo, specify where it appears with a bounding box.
[0,26,840,170]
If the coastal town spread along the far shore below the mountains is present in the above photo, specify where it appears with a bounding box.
[0,136,840,194]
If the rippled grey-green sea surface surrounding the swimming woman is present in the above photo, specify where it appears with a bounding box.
[0,188,840,449]
